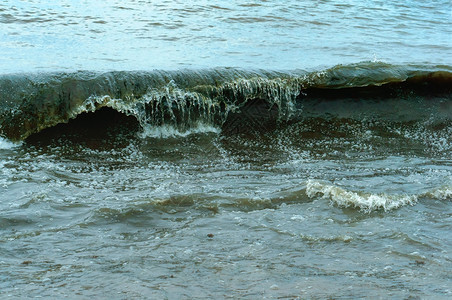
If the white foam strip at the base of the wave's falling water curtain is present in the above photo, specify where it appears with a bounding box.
[140,123,221,138]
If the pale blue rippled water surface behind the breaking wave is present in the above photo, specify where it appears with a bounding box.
[0,0,452,72]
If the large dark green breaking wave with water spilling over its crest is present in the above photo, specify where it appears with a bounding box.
[0,62,452,141]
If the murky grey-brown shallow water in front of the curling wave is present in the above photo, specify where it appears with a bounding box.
[1,104,452,298]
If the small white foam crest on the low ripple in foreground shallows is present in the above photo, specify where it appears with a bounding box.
[306,180,417,212]
